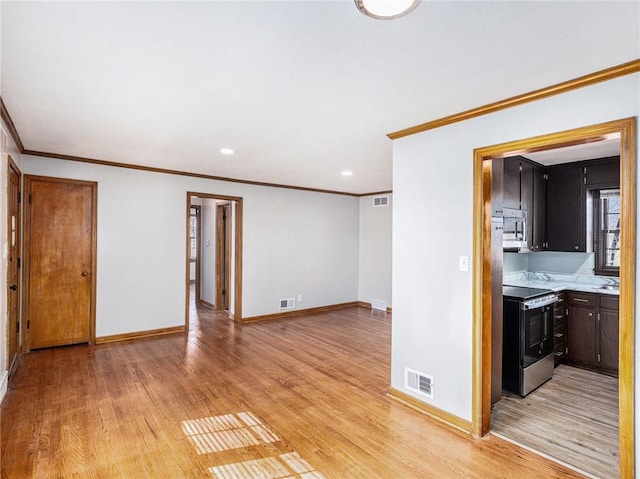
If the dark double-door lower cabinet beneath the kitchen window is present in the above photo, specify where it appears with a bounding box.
[566,291,619,375]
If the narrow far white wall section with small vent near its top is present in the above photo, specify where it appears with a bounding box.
[358,194,393,307]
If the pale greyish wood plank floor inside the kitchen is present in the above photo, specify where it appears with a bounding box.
[491,365,619,479]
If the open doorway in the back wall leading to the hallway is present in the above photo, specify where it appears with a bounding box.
[186,192,242,329]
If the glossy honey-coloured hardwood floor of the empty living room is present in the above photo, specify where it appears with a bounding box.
[1,307,583,479]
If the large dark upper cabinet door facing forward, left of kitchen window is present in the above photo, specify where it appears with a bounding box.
[547,166,586,252]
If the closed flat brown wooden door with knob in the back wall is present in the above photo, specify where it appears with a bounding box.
[25,176,97,349]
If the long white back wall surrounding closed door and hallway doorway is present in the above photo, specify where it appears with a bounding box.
[23,155,359,336]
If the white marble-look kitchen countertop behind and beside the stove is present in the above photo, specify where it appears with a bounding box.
[502,271,620,296]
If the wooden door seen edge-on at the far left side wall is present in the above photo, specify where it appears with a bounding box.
[7,157,21,373]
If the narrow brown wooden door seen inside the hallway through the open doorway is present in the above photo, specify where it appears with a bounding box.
[216,203,231,311]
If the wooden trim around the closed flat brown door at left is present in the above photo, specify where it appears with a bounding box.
[21,175,98,352]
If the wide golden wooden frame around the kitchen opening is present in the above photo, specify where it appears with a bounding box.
[472,117,636,477]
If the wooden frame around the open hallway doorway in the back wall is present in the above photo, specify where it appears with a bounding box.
[185,191,243,324]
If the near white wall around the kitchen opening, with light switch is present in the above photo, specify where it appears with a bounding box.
[391,74,640,432]
